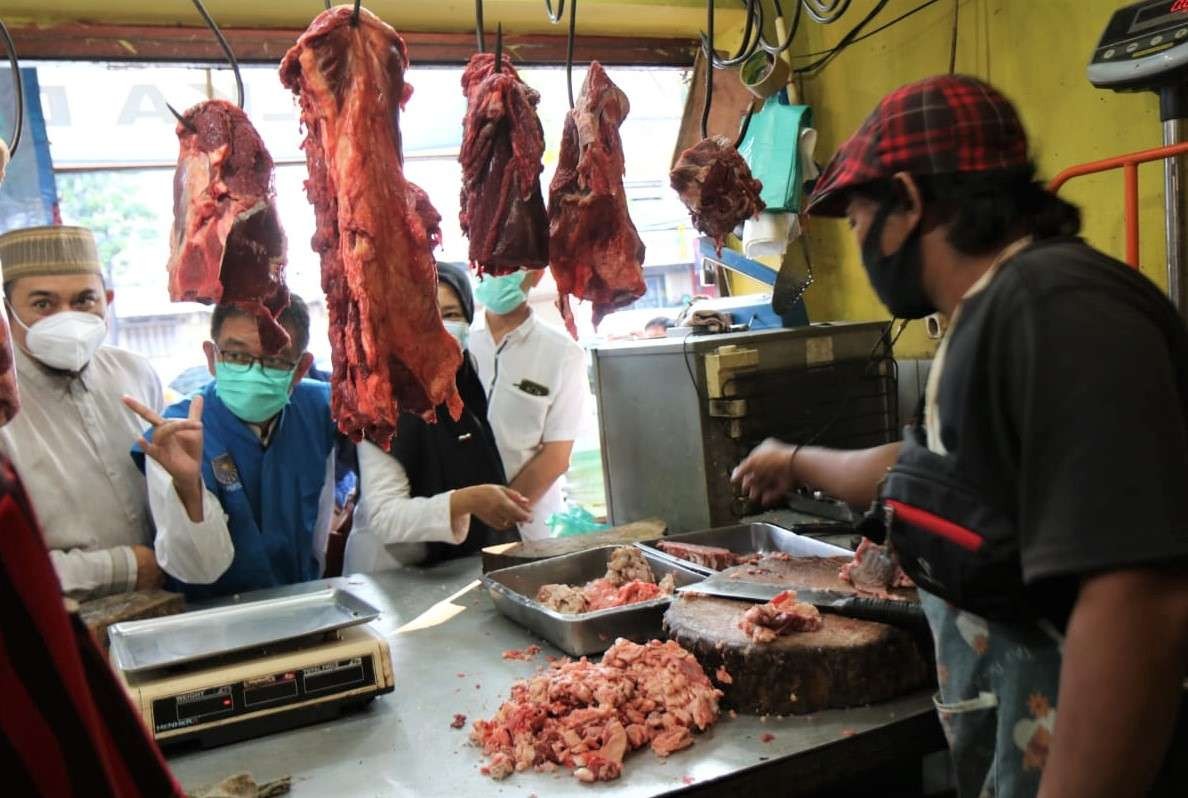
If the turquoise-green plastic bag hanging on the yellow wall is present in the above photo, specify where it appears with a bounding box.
[739,89,813,213]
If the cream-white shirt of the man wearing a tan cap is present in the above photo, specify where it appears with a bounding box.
[0,346,164,600]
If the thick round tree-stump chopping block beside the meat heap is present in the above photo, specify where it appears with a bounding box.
[664,594,931,715]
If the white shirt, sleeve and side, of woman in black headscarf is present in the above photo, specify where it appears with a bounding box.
[342,441,470,575]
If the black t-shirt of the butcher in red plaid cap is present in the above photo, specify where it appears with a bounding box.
[937,239,1188,626]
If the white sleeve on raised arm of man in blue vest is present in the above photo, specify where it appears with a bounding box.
[145,457,235,584]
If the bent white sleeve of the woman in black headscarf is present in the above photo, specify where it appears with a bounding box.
[354,441,470,545]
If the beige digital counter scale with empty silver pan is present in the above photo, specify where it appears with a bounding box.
[109,589,393,747]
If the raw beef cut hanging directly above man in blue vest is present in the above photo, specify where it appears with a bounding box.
[169,100,289,353]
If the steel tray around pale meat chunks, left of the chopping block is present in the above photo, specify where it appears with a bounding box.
[482,546,704,657]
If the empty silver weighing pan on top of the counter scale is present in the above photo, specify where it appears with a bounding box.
[108,588,379,672]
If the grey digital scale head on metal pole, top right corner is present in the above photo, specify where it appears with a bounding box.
[1087,0,1188,314]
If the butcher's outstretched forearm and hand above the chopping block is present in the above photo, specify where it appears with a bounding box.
[732,439,902,507]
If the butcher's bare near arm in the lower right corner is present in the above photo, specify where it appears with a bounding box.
[1040,568,1188,798]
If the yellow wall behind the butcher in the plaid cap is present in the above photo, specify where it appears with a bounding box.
[735,0,1165,357]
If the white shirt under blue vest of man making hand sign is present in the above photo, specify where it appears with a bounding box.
[145,424,334,584]
